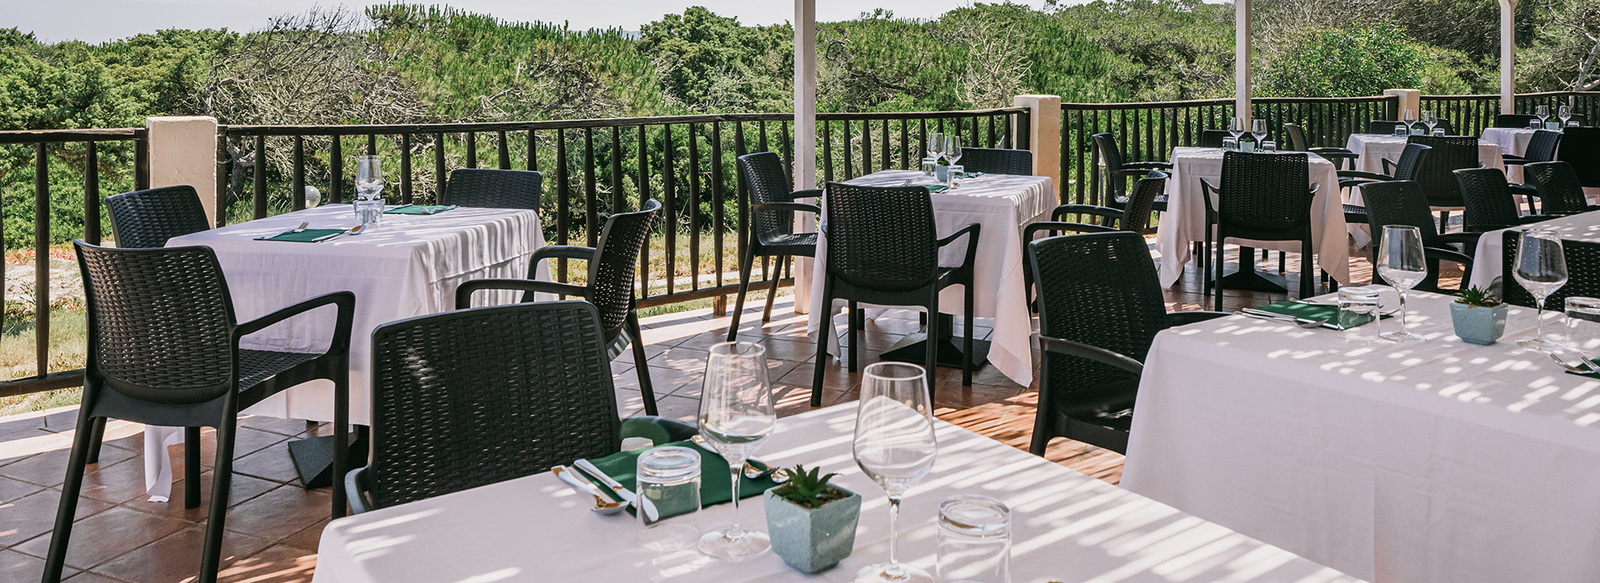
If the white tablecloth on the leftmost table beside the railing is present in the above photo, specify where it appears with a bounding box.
[146,205,549,497]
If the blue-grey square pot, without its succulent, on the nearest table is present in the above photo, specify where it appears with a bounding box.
[763,485,861,575]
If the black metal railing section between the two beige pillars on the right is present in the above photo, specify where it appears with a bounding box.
[1059,96,1398,203]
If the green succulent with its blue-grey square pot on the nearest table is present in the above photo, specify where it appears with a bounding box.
[763,466,861,575]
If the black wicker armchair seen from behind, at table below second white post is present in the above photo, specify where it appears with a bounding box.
[1200,152,1322,309]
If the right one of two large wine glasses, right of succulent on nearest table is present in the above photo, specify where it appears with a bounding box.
[854,362,939,583]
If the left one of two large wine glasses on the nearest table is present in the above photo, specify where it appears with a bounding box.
[699,343,778,561]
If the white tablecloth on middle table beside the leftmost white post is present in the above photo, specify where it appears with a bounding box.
[806,170,1058,386]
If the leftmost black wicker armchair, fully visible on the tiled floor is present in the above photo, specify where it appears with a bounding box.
[43,240,355,583]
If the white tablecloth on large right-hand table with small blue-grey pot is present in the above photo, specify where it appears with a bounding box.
[1122,292,1600,583]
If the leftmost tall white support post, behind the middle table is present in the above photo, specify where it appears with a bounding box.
[794,0,822,314]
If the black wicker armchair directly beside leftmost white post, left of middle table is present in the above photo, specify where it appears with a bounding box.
[728,152,825,343]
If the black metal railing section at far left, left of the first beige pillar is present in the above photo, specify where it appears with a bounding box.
[0,128,150,397]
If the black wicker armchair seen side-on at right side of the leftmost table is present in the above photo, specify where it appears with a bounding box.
[456,200,661,415]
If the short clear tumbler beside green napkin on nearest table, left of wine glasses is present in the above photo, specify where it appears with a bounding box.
[634,445,701,553]
